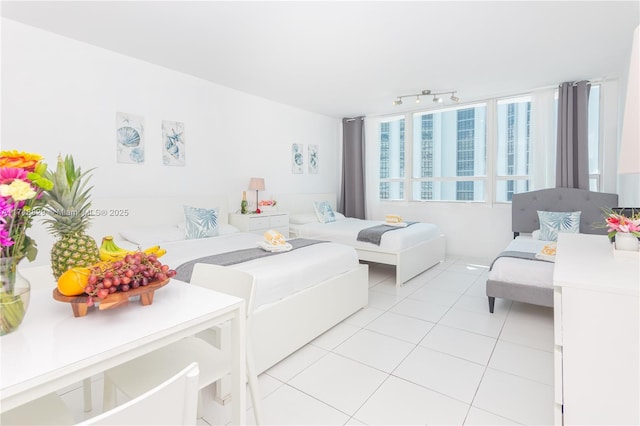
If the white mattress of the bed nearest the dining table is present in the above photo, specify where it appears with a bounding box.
[161,232,359,308]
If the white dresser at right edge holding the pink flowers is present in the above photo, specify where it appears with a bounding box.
[553,234,640,425]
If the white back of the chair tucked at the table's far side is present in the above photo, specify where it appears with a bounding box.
[190,263,255,317]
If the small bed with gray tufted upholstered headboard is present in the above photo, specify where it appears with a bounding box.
[486,188,618,313]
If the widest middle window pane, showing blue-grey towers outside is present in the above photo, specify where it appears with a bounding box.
[411,104,486,201]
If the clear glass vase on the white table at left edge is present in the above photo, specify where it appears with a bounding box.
[0,257,31,336]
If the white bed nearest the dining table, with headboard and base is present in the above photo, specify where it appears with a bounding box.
[84,195,368,373]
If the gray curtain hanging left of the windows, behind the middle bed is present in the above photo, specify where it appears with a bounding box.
[338,117,365,219]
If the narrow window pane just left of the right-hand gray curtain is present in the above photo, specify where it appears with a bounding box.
[495,96,531,202]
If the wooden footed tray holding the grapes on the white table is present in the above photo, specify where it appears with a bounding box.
[53,278,170,318]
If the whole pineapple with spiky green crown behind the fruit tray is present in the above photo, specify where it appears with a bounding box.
[44,155,100,280]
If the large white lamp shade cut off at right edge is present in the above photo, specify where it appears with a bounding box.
[618,27,640,174]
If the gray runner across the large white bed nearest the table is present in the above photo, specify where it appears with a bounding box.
[175,238,327,283]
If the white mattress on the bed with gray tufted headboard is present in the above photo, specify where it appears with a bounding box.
[489,236,554,288]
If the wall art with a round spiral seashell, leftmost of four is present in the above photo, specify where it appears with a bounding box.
[116,112,144,164]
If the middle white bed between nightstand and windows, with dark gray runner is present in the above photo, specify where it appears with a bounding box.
[278,193,445,286]
